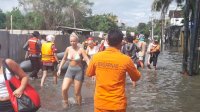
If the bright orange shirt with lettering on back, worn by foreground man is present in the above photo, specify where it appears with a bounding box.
[86,47,140,110]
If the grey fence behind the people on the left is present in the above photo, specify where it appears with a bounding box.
[0,31,70,62]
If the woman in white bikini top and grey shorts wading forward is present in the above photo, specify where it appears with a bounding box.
[57,33,89,108]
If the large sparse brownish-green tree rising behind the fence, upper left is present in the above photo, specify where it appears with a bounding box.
[18,0,92,29]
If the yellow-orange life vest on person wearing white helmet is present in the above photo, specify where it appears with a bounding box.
[41,42,56,62]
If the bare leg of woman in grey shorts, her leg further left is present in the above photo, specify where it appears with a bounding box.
[62,77,73,108]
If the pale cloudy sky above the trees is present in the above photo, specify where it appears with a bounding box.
[0,0,176,26]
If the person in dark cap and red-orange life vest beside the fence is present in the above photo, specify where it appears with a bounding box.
[23,31,41,78]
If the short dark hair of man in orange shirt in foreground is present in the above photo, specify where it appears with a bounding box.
[107,29,123,46]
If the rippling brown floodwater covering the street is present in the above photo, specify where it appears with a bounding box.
[30,47,200,112]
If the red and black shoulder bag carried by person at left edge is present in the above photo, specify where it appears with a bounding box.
[2,59,40,112]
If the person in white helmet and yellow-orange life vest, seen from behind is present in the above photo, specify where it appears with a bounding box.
[40,35,59,87]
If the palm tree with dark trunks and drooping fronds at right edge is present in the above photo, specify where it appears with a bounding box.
[152,0,200,75]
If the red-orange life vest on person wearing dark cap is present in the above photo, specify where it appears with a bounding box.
[28,37,40,54]
